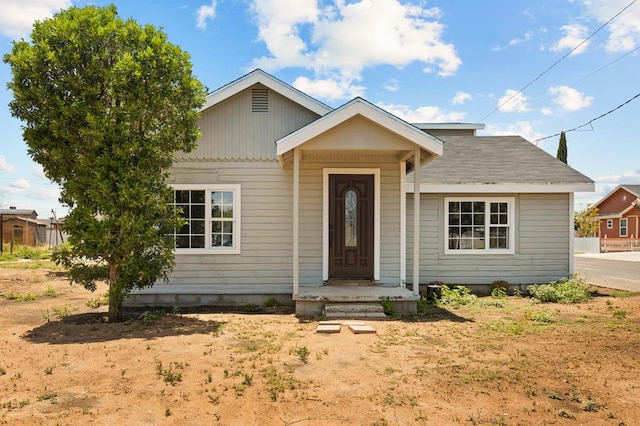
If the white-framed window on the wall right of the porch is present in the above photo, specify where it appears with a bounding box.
[444,197,515,254]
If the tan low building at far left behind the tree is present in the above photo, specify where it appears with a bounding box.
[0,207,47,246]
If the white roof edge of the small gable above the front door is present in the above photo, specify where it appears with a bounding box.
[276,97,443,160]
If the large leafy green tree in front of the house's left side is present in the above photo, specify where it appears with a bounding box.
[4,5,205,321]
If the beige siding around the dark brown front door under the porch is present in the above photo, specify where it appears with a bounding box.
[300,162,400,286]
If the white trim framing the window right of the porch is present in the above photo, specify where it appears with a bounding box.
[443,197,516,255]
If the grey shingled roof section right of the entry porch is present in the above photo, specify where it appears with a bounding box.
[407,136,594,192]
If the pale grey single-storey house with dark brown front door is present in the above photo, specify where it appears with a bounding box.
[126,70,593,315]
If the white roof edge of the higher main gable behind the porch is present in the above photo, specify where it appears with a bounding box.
[200,68,332,115]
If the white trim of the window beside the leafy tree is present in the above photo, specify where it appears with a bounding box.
[171,184,242,255]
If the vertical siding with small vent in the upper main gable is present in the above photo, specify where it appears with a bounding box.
[176,85,319,160]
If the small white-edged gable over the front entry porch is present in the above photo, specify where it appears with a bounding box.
[276,98,443,166]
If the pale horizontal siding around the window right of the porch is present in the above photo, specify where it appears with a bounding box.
[407,193,571,285]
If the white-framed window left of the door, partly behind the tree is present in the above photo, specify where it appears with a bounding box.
[173,185,241,254]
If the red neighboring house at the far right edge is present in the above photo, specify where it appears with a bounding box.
[593,185,640,251]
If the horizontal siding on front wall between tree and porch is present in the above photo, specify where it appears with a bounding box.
[156,160,293,294]
